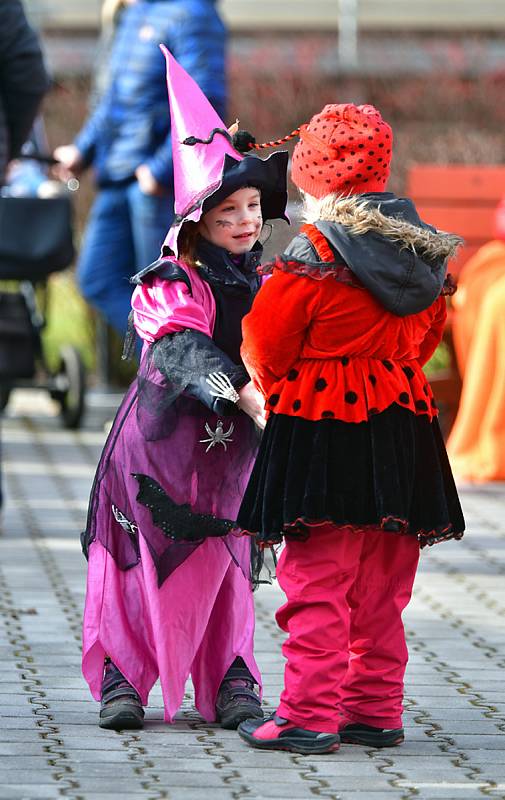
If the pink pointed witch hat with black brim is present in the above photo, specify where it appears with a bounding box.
[160,45,289,256]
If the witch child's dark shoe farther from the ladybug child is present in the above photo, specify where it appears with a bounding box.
[98,659,144,731]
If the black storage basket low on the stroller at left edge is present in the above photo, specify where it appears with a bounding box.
[0,292,37,381]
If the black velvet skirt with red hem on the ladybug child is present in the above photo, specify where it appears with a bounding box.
[238,404,465,546]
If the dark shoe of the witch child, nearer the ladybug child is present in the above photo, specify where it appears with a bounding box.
[216,658,263,730]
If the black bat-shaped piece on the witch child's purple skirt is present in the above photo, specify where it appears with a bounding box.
[133,473,236,542]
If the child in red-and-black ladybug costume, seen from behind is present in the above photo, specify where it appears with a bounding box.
[238,104,464,753]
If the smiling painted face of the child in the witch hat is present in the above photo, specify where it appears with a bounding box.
[198,186,263,256]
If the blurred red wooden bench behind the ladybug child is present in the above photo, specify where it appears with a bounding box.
[406,164,505,435]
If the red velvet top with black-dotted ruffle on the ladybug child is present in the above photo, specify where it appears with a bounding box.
[242,269,447,422]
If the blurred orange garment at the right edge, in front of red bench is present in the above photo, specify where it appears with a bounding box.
[447,240,505,482]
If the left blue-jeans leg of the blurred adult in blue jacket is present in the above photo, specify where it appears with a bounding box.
[77,187,136,334]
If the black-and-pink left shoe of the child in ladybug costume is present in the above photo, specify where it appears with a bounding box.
[238,714,340,756]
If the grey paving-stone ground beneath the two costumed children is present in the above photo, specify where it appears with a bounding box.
[0,394,505,800]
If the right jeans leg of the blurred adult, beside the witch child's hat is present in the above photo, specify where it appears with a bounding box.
[128,183,174,268]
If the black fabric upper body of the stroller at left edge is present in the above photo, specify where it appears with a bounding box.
[0,194,74,281]
